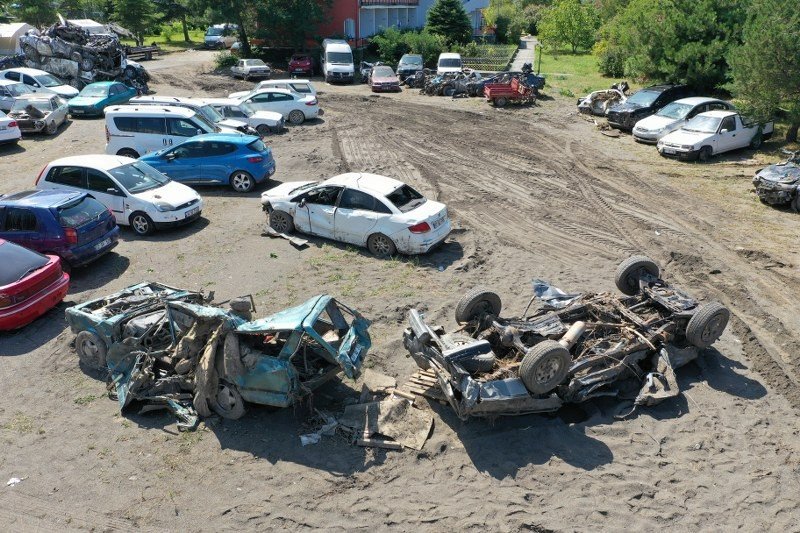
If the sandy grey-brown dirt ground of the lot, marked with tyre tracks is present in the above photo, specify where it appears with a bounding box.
[0,48,800,532]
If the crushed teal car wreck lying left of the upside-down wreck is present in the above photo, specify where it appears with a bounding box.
[66,283,371,428]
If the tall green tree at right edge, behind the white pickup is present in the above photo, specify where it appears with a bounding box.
[729,0,800,141]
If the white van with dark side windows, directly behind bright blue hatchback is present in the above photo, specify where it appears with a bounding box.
[106,105,222,159]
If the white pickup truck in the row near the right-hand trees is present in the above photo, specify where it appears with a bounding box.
[657,110,774,161]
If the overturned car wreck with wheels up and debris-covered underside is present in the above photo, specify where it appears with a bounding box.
[403,256,729,419]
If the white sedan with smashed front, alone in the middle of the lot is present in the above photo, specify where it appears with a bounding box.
[261,172,451,257]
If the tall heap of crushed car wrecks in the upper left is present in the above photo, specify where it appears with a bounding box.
[20,19,149,93]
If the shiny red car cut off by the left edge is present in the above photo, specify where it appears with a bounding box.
[0,239,69,331]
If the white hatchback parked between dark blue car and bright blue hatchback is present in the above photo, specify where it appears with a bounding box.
[36,154,203,235]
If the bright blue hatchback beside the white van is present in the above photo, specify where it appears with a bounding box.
[139,133,275,192]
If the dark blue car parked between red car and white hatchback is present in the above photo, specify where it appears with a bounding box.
[0,190,119,268]
